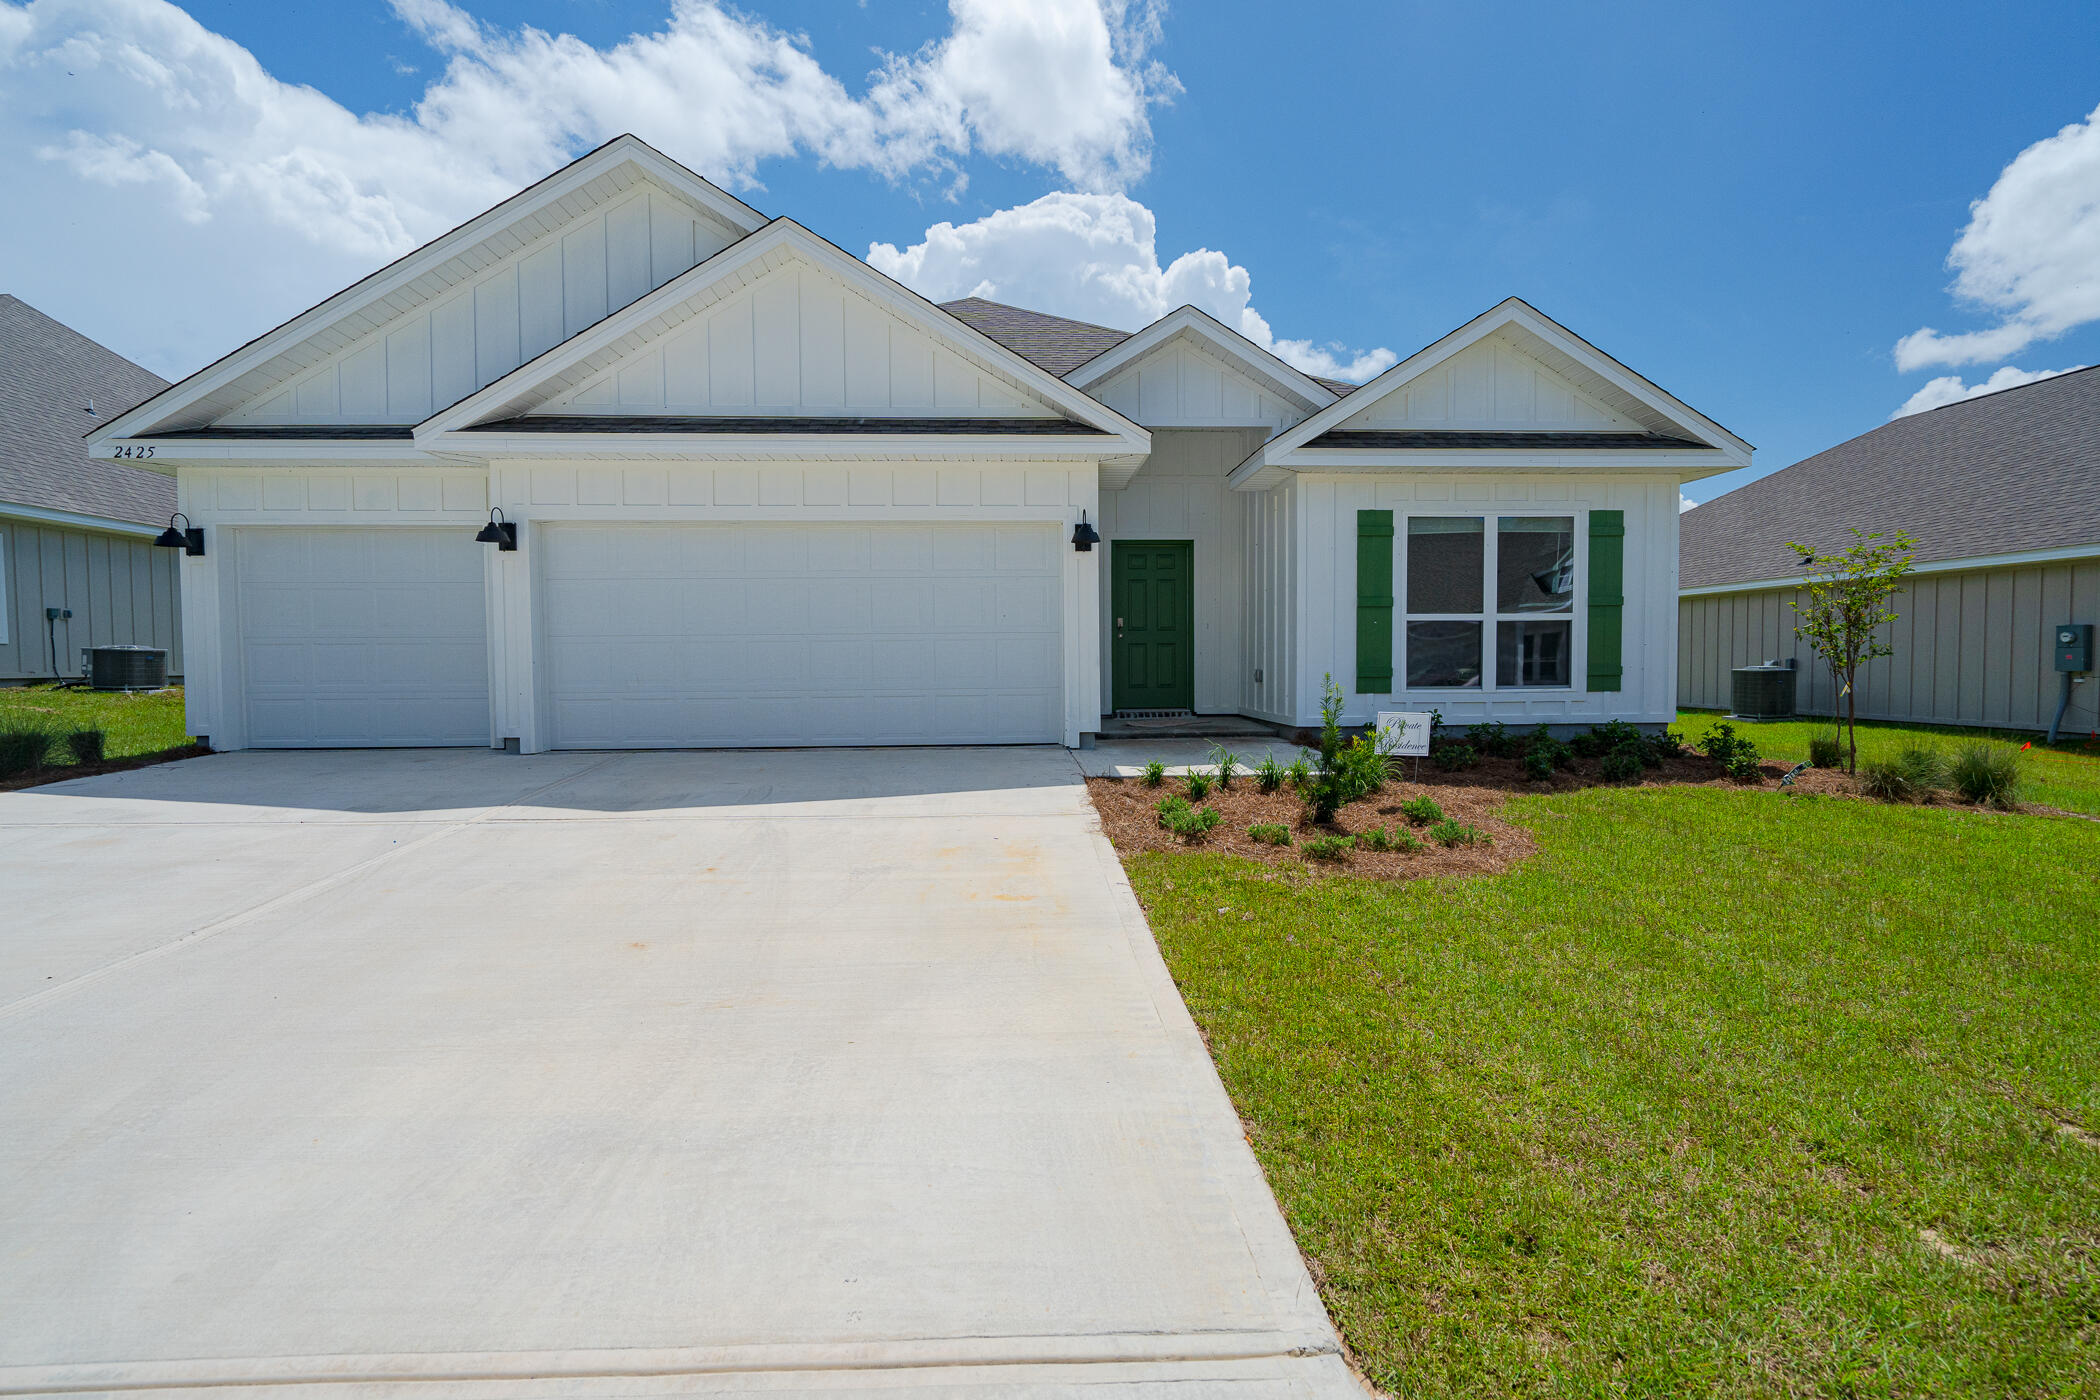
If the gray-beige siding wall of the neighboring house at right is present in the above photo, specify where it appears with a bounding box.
[1678,558,2100,735]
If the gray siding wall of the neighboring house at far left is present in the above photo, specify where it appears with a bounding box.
[0,518,183,684]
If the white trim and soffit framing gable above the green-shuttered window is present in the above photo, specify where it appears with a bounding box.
[1226,296,1751,491]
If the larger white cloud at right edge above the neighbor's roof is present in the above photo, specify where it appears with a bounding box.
[1896,109,2100,371]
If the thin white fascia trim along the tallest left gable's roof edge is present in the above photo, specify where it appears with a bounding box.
[88,134,767,445]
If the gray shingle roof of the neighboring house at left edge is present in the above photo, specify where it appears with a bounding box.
[0,292,174,525]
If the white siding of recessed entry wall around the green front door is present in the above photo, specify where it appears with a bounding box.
[1100,428,1268,714]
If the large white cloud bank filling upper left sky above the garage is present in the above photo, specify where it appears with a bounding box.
[0,0,1178,374]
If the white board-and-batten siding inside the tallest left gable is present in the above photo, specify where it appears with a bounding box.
[221,189,735,426]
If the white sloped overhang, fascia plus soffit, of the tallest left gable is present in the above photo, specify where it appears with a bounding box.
[88,134,767,455]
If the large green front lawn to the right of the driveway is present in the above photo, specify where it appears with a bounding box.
[1130,785,2100,1396]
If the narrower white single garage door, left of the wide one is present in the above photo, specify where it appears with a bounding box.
[233,525,489,747]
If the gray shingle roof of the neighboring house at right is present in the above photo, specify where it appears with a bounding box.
[1678,367,2100,588]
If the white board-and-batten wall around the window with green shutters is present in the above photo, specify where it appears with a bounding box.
[1289,472,1678,728]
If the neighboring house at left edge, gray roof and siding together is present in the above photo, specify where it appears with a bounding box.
[0,294,183,684]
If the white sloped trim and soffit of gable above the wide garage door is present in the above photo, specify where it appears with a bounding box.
[416,218,1151,468]
